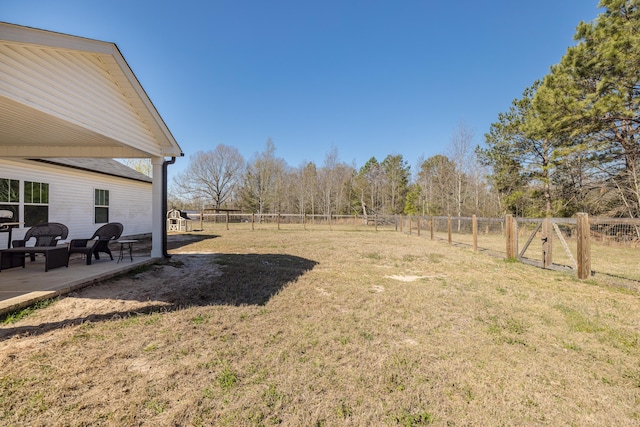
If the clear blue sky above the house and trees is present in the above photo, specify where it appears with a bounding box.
[0,0,601,177]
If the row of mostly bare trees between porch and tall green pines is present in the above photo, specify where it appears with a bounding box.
[169,123,498,216]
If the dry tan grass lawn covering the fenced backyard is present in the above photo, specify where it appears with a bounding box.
[0,226,640,426]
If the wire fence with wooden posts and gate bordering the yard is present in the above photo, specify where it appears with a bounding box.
[179,213,640,289]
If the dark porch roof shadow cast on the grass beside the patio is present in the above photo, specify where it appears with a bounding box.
[0,254,317,340]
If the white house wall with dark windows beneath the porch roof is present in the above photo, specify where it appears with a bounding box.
[0,158,152,249]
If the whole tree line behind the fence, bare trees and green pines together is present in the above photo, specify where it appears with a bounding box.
[170,0,640,218]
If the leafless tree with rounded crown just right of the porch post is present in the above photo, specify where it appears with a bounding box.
[174,144,244,208]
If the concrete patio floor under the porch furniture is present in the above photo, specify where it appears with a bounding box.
[0,251,157,315]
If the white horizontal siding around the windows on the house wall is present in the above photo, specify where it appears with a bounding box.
[0,159,152,248]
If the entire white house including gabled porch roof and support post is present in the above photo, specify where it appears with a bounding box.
[0,22,182,257]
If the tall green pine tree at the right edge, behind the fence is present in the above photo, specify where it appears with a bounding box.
[535,0,640,217]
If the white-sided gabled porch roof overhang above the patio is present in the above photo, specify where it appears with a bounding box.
[0,22,182,158]
